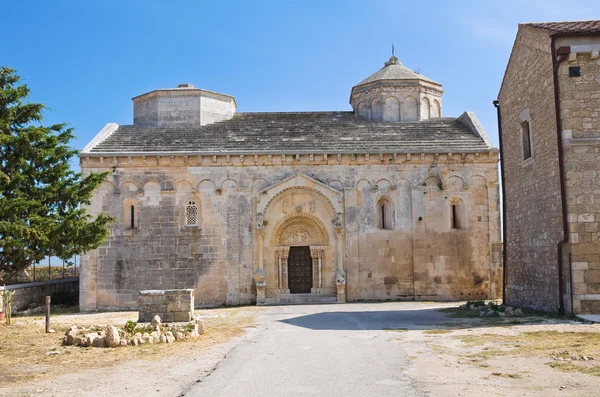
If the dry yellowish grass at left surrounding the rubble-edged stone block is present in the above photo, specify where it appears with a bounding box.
[0,307,262,384]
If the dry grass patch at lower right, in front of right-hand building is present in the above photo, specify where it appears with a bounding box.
[454,331,600,376]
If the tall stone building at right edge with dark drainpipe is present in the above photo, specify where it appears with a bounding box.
[497,21,600,313]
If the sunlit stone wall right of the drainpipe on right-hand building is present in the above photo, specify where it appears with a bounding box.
[558,48,600,313]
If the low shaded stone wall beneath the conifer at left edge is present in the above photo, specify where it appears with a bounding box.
[0,277,79,313]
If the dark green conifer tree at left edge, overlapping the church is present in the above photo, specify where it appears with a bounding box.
[0,67,112,280]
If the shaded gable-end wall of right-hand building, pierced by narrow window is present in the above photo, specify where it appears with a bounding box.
[499,26,563,311]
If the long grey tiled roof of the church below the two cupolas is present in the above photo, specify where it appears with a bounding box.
[82,112,496,155]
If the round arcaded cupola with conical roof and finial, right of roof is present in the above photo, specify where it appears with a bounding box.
[350,47,444,122]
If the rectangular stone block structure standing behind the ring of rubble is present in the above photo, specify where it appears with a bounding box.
[138,289,194,322]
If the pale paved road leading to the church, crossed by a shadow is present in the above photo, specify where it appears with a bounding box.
[182,303,448,397]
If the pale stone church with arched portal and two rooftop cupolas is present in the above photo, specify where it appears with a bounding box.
[80,56,502,310]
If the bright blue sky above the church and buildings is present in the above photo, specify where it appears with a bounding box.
[0,0,600,156]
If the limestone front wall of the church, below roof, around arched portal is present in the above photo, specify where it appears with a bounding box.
[81,153,502,310]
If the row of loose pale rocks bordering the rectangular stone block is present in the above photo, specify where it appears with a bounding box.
[62,316,204,348]
